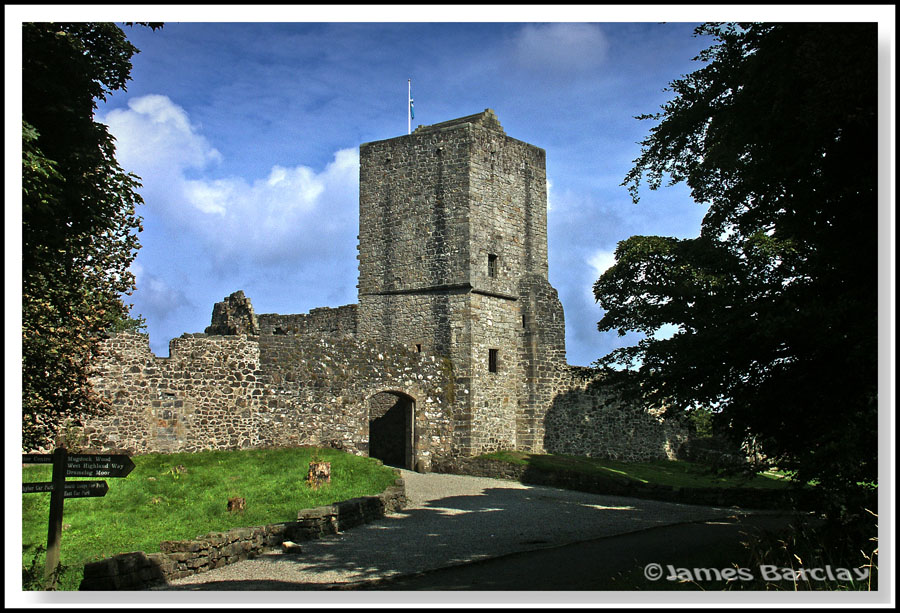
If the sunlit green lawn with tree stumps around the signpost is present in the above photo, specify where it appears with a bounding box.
[22,447,396,590]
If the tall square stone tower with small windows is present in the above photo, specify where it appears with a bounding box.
[358,109,565,455]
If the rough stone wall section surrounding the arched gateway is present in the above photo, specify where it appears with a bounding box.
[258,334,455,463]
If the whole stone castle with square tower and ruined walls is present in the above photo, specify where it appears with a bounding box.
[83,109,685,471]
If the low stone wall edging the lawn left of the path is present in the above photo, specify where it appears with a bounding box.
[79,478,406,590]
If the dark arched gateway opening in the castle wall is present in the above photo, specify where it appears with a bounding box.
[369,392,416,470]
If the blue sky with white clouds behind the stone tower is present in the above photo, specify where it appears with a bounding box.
[7,6,892,365]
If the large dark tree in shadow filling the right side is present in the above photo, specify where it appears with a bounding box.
[594,23,878,510]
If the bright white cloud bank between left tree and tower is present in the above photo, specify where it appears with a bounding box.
[103,95,359,264]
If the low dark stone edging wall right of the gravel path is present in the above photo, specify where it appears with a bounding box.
[433,458,809,509]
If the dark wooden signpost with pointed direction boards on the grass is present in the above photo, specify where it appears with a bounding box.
[22,447,134,588]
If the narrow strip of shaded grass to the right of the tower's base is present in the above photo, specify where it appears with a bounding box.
[480,451,790,489]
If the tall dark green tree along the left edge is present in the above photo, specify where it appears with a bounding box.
[22,23,161,449]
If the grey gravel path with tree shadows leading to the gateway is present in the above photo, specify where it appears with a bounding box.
[158,471,752,590]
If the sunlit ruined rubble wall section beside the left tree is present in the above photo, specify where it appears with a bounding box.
[85,333,266,453]
